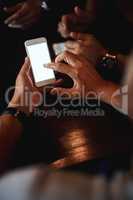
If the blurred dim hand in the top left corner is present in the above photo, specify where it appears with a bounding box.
[4,0,41,29]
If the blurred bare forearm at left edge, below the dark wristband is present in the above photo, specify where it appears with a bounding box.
[0,115,22,172]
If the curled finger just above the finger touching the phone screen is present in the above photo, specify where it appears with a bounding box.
[55,51,79,67]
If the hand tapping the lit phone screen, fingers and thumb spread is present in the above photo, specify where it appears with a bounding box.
[48,52,106,97]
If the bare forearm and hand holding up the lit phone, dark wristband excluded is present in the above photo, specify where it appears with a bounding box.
[0,59,42,172]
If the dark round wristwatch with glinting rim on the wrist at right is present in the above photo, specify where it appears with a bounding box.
[100,53,118,69]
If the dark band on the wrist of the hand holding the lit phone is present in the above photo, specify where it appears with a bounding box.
[2,107,29,125]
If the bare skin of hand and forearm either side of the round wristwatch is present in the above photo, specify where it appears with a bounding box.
[65,32,129,74]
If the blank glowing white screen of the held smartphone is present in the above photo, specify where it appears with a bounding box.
[27,42,55,83]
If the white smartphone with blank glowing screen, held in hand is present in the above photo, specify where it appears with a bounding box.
[25,38,55,87]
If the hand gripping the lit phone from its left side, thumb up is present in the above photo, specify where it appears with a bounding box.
[9,58,42,113]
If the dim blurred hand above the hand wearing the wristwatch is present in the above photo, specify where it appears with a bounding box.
[58,7,93,38]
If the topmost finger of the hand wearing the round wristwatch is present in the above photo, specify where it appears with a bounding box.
[70,32,92,41]
